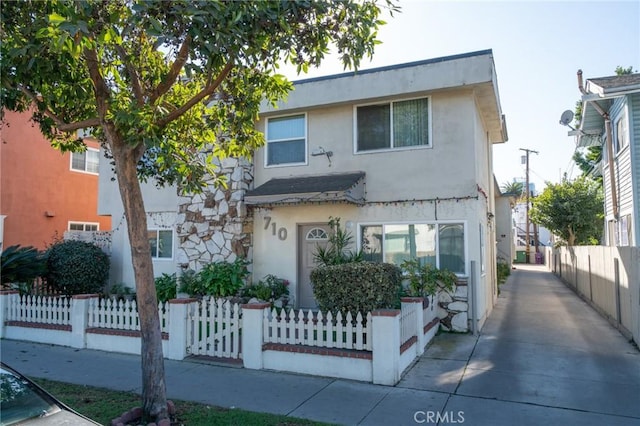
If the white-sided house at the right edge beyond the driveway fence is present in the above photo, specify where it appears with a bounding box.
[575,73,640,246]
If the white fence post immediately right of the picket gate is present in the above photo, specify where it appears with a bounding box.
[241,303,271,370]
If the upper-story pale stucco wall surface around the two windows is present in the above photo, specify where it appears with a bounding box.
[254,90,477,201]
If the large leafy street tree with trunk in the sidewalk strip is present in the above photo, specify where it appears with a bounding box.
[0,0,397,421]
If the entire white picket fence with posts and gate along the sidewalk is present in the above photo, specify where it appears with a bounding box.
[0,291,437,385]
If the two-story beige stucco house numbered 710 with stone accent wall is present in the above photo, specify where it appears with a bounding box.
[100,50,507,328]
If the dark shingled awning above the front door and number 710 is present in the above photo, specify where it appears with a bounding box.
[244,172,365,206]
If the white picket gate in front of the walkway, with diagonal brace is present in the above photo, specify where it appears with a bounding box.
[187,299,242,359]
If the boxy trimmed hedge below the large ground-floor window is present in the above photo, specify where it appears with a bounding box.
[311,262,402,314]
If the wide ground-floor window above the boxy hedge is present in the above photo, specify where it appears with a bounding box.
[360,223,466,275]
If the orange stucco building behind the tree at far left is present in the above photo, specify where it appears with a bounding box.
[0,111,111,249]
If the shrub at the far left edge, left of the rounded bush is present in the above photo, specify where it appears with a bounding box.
[0,245,47,285]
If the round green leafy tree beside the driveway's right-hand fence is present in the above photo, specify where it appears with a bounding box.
[530,176,604,246]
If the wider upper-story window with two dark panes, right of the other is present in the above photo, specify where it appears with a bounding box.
[356,98,431,152]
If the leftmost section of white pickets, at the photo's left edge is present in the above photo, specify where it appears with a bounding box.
[6,295,71,325]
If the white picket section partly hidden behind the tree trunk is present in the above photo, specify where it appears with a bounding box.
[87,298,169,333]
